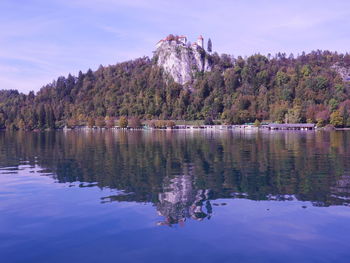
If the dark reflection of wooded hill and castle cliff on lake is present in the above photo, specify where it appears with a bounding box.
[0,131,350,225]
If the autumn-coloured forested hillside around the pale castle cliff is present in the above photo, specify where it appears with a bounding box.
[0,51,350,129]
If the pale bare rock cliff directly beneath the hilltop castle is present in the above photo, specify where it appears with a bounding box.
[155,41,211,85]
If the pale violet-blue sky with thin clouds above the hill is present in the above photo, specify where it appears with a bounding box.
[0,0,350,93]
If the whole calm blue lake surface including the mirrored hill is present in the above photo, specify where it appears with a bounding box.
[0,131,350,263]
